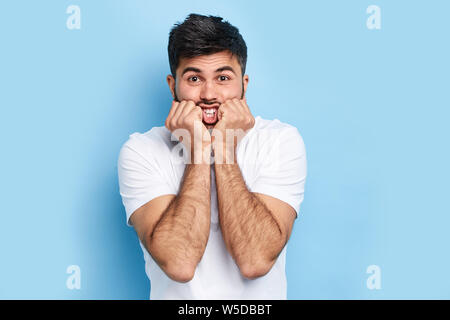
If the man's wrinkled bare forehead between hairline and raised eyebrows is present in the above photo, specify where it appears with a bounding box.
[177,51,240,73]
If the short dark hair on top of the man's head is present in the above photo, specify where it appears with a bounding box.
[167,13,247,78]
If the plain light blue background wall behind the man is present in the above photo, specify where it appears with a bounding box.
[0,0,450,299]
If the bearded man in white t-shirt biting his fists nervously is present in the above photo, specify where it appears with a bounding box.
[118,14,306,299]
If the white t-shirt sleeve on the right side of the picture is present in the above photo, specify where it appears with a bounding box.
[250,126,306,218]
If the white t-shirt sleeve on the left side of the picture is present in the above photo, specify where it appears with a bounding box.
[117,138,175,226]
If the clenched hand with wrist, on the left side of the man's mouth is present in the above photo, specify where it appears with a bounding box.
[165,100,211,163]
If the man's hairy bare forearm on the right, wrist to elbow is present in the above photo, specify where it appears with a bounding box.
[215,163,283,271]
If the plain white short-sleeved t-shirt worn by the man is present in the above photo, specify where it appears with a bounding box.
[118,116,306,300]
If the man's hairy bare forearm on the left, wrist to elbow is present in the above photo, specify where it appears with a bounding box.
[149,164,211,270]
